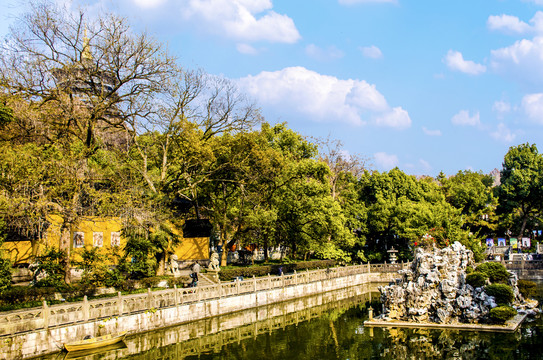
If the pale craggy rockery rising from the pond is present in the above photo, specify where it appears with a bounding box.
[379,242,536,323]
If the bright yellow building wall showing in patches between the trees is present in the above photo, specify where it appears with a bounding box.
[2,215,209,263]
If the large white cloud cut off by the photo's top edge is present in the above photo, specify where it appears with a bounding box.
[182,0,301,43]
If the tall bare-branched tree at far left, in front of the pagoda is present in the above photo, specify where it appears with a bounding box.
[0,1,175,282]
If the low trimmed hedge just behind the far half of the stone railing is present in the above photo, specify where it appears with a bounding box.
[219,260,337,281]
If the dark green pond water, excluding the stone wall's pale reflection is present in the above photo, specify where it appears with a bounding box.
[185,307,543,360]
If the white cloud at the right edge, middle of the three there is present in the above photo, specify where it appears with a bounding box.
[490,36,543,86]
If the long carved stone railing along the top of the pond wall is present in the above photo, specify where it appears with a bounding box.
[0,263,408,337]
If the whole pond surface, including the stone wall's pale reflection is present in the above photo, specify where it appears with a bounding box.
[34,284,543,360]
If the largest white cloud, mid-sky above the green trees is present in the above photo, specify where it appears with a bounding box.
[239,67,411,129]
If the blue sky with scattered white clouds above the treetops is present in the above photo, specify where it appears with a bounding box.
[0,0,543,176]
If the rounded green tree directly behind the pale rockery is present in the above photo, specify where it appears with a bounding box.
[358,169,481,261]
